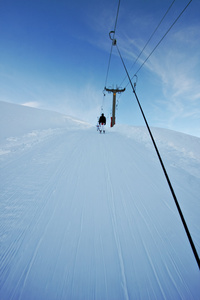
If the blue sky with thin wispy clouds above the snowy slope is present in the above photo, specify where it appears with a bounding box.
[0,0,200,136]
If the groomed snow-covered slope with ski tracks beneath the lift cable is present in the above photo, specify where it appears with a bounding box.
[0,102,200,300]
